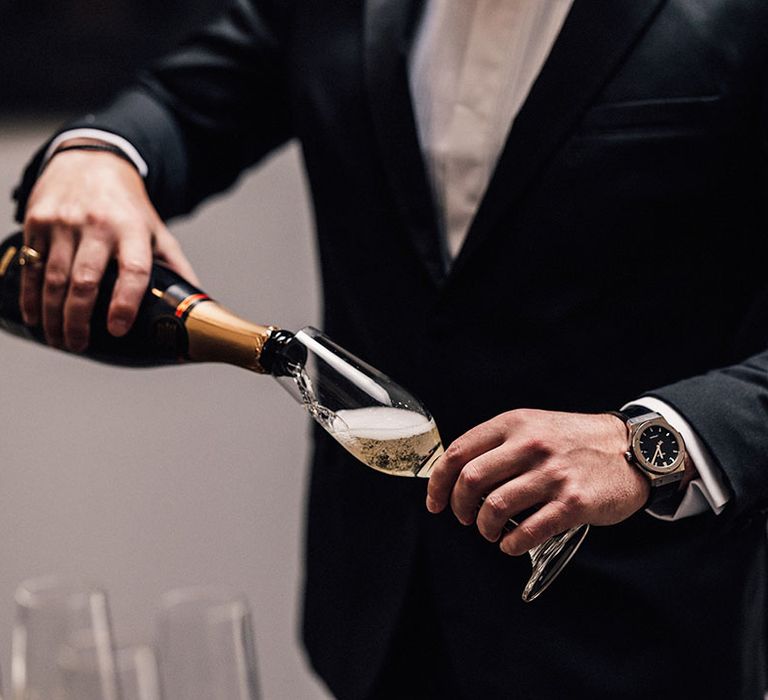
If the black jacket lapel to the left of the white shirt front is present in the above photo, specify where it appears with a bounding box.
[364,0,445,283]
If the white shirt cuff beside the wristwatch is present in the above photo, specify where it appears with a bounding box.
[624,396,731,520]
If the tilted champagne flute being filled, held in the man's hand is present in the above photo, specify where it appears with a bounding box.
[278,327,589,602]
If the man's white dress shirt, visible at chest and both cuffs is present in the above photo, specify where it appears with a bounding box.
[48,0,729,520]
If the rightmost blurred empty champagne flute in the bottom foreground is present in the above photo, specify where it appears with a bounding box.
[157,587,260,700]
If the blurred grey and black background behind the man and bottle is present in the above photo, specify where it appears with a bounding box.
[0,0,329,700]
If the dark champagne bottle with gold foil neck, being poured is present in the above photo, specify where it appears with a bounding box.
[0,233,304,376]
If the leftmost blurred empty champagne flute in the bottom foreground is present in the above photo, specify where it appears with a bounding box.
[11,576,120,700]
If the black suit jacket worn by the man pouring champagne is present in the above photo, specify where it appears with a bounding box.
[19,0,768,699]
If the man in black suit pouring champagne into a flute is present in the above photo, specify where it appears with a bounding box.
[13,0,768,700]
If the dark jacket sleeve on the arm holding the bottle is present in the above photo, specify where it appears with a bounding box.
[14,0,292,221]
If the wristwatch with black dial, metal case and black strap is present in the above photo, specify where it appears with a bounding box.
[610,405,685,508]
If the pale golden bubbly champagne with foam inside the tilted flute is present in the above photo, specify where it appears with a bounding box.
[329,406,443,476]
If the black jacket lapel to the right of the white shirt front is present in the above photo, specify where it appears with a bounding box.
[451,0,665,284]
